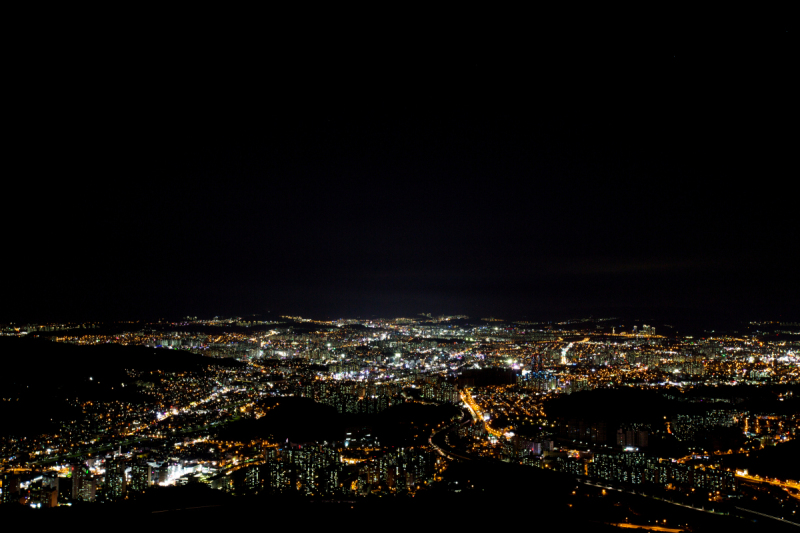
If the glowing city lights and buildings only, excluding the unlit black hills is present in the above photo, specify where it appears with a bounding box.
[0,314,800,516]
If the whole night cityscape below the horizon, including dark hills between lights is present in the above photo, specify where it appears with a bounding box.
[0,313,800,531]
